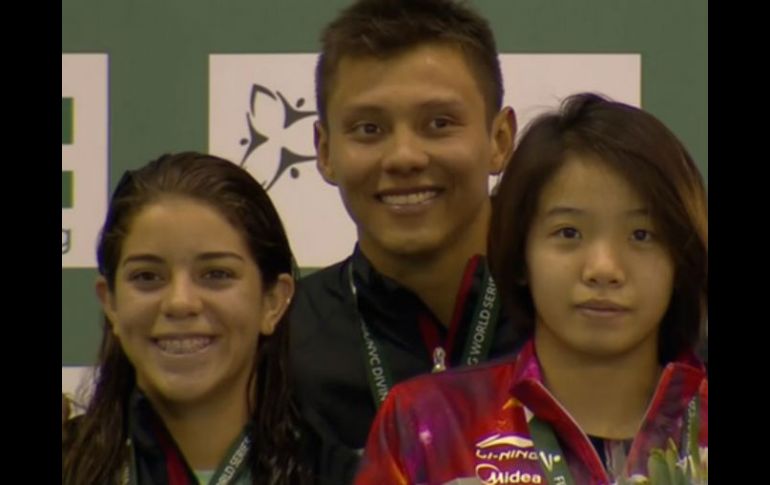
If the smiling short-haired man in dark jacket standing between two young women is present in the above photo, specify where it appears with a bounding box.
[291,0,517,483]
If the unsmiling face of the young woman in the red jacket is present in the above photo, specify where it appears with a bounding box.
[526,155,674,358]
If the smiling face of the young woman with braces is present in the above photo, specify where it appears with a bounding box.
[97,197,293,403]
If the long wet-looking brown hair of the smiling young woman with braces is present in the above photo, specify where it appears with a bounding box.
[62,152,306,485]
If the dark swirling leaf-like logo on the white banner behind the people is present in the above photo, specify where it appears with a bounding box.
[240,84,317,190]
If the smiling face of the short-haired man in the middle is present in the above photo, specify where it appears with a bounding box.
[317,44,515,268]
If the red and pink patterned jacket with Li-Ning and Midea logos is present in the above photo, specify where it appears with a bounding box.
[355,341,708,485]
